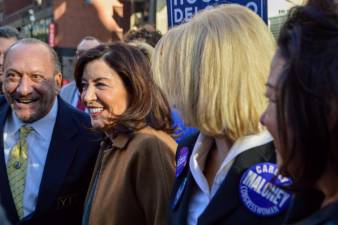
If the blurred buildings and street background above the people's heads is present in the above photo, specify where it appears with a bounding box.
[0,0,302,80]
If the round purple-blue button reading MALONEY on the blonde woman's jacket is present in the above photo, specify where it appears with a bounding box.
[239,163,292,217]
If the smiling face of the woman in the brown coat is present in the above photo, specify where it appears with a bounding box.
[81,59,128,129]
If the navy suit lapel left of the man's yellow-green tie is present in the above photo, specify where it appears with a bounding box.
[0,103,19,224]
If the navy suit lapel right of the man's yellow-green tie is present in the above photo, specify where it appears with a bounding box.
[35,98,79,216]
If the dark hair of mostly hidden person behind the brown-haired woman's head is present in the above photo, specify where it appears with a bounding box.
[124,25,162,47]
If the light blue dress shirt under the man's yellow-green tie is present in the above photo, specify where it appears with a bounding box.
[3,100,58,216]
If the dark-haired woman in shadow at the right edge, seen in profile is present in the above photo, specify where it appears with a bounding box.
[261,0,338,225]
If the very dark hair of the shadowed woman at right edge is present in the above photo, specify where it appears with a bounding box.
[277,0,338,187]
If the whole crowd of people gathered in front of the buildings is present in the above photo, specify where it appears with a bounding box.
[0,0,338,225]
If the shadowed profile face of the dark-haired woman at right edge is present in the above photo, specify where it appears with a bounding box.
[261,52,285,165]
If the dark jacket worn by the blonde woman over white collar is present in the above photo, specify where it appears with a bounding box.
[169,134,285,225]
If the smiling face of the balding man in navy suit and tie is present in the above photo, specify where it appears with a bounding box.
[3,43,62,123]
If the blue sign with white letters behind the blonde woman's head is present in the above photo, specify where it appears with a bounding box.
[167,0,268,28]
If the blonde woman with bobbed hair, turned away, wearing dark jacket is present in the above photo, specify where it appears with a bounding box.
[153,5,291,225]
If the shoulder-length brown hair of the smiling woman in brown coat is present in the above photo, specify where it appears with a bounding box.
[75,42,174,134]
